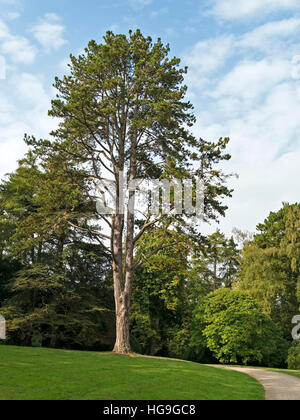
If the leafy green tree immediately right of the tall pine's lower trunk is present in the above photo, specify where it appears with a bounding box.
[131,229,191,358]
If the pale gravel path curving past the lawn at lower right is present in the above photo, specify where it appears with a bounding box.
[225,366,300,401]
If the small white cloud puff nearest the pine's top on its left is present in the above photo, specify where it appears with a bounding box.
[30,13,67,52]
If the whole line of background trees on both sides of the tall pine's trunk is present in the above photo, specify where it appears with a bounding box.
[0,153,300,366]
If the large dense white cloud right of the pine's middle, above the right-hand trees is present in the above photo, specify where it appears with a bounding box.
[197,81,300,234]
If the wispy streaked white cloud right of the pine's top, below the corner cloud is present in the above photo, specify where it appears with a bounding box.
[183,18,300,98]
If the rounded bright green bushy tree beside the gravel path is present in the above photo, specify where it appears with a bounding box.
[191,289,288,366]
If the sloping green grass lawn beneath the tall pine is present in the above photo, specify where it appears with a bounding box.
[0,346,264,400]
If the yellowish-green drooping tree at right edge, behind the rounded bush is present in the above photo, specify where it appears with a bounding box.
[238,205,300,339]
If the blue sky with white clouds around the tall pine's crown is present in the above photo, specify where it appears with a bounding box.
[0,0,300,234]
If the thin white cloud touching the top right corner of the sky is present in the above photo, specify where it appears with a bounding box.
[210,0,300,20]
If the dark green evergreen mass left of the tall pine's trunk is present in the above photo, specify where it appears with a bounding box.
[0,155,114,349]
